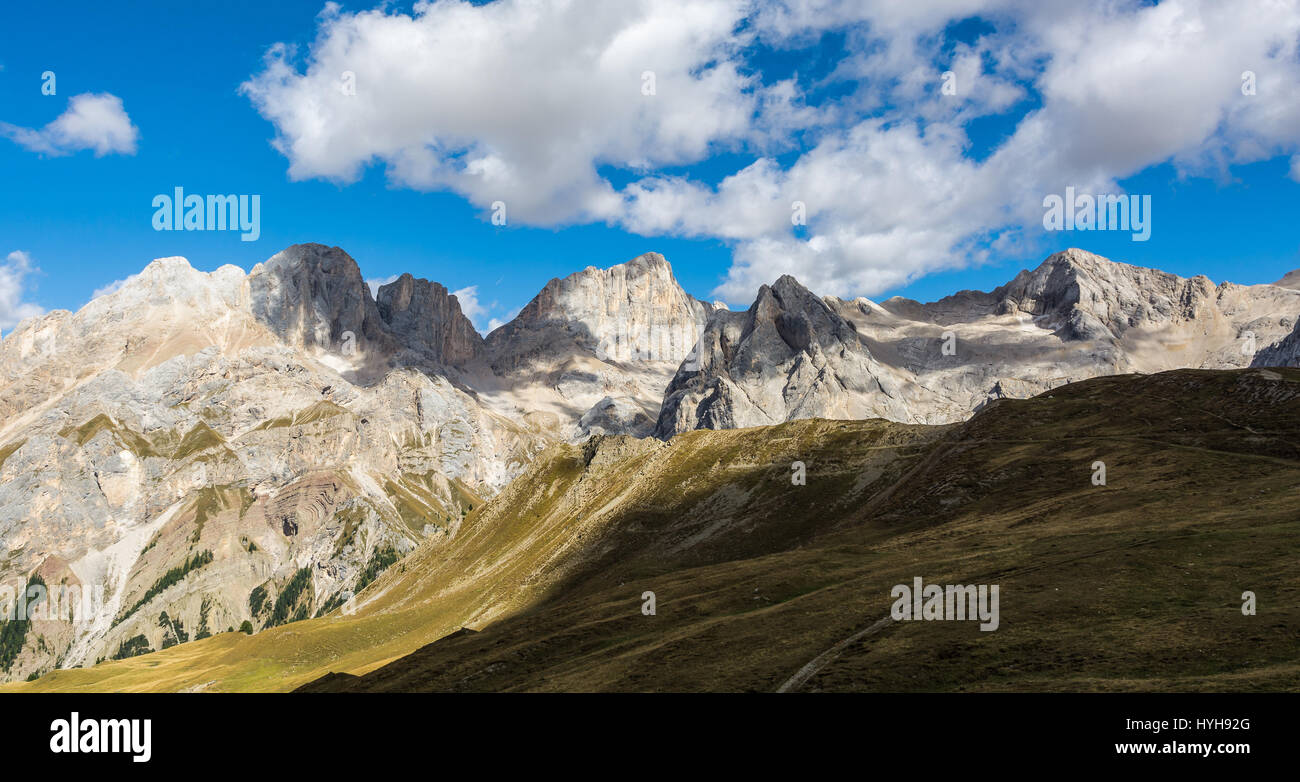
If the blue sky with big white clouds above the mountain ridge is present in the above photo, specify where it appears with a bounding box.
[0,0,1300,331]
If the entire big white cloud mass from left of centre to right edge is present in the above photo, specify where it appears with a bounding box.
[243,0,1300,303]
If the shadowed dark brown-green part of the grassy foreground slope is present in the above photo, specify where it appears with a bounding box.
[297,370,1300,691]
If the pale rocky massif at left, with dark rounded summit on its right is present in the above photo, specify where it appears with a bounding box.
[0,244,527,679]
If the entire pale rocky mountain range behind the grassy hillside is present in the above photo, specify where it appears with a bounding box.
[0,244,1300,683]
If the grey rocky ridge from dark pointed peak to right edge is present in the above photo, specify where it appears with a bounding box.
[655,249,1300,438]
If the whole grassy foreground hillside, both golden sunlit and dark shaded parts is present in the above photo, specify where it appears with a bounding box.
[8,369,1300,691]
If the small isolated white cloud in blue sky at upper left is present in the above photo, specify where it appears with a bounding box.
[0,92,140,157]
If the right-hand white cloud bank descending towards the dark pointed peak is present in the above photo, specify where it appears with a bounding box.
[634,0,1300,303]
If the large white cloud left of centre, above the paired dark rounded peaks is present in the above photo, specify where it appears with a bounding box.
[242,0,758,225]
